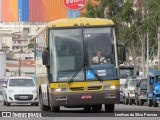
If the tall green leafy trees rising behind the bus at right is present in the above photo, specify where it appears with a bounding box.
[83,0,160,71]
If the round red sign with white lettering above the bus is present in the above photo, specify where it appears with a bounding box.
[64,0,86,10]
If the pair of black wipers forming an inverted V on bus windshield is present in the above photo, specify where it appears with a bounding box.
[68,64,103,83]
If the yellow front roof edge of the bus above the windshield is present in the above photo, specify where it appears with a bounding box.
[47,17,114,27]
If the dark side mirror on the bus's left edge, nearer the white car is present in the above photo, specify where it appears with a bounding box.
[42,49,49,66]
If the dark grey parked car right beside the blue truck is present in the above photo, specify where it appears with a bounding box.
[135,78,147,105]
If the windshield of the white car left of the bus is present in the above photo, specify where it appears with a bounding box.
[9,79,35,87]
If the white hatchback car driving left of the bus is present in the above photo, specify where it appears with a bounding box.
[3,77,39,106]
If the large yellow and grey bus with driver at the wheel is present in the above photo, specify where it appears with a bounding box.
[36,18,120,112]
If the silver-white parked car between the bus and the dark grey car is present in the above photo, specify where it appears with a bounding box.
[123,77,139,105]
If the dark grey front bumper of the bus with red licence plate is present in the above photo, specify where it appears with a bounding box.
[50,90,120,107]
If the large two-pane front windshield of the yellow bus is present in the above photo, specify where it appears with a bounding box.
[49,27,115,82]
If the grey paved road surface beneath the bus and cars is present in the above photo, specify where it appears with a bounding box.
[0,102,160,114]
